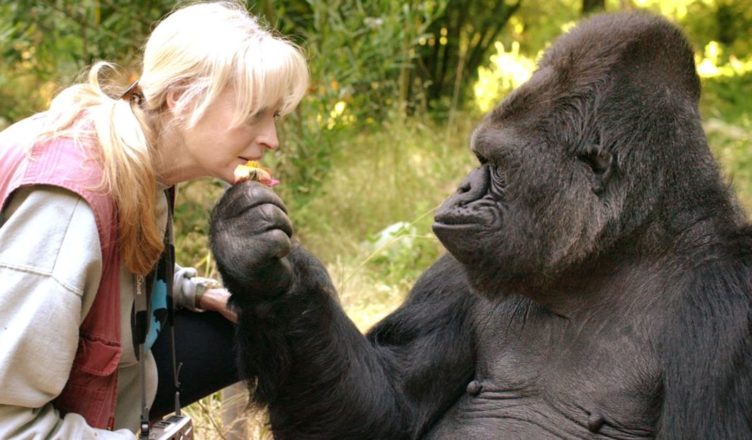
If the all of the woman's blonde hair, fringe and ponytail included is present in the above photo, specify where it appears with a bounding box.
[37,1,308,275]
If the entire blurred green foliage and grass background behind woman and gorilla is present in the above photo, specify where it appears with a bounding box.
[0,0,752,439]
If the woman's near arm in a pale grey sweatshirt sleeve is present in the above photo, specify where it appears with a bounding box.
[0,186,134,439]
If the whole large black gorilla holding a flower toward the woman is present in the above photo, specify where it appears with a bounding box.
[211,12,752,440]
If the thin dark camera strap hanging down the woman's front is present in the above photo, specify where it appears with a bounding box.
[134,187,182,439]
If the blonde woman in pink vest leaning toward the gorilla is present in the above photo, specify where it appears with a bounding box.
[0,2,308,439]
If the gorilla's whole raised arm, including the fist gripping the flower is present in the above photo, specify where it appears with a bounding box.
[212,183,478,439]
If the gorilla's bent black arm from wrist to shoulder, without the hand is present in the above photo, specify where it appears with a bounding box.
[253,248,474,439]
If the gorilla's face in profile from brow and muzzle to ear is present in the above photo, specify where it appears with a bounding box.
[433,68,620,294]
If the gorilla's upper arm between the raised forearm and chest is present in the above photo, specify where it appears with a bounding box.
[367,256,482,438]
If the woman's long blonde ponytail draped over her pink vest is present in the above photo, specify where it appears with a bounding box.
[45,62,164,275]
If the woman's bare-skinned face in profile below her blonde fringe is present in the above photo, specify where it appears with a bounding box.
[175,88,279,183]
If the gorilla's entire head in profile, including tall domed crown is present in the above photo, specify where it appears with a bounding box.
[434,15,704,295]
